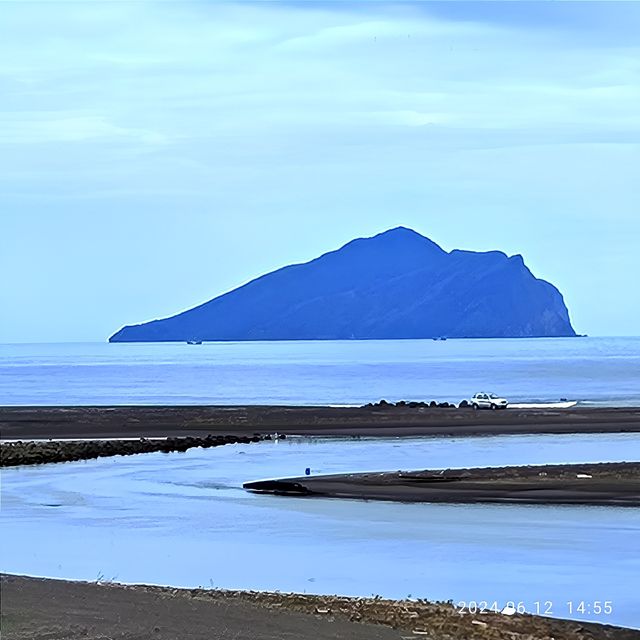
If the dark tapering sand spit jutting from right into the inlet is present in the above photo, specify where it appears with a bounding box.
[243,462,640,507]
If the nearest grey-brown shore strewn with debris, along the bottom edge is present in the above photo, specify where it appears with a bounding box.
[1,575,640,640]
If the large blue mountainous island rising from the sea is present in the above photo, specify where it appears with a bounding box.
[109,227,576,342]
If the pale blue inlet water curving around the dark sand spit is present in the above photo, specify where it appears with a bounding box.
[1,434,640,628]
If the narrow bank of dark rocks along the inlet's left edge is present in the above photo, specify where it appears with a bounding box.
[0,435,271,467]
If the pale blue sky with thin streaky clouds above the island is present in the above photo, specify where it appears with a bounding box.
[0,0,640,342]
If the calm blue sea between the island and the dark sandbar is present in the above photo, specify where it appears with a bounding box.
[0,338,640,405]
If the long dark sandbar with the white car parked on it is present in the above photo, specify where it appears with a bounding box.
[0,404,640,440]
